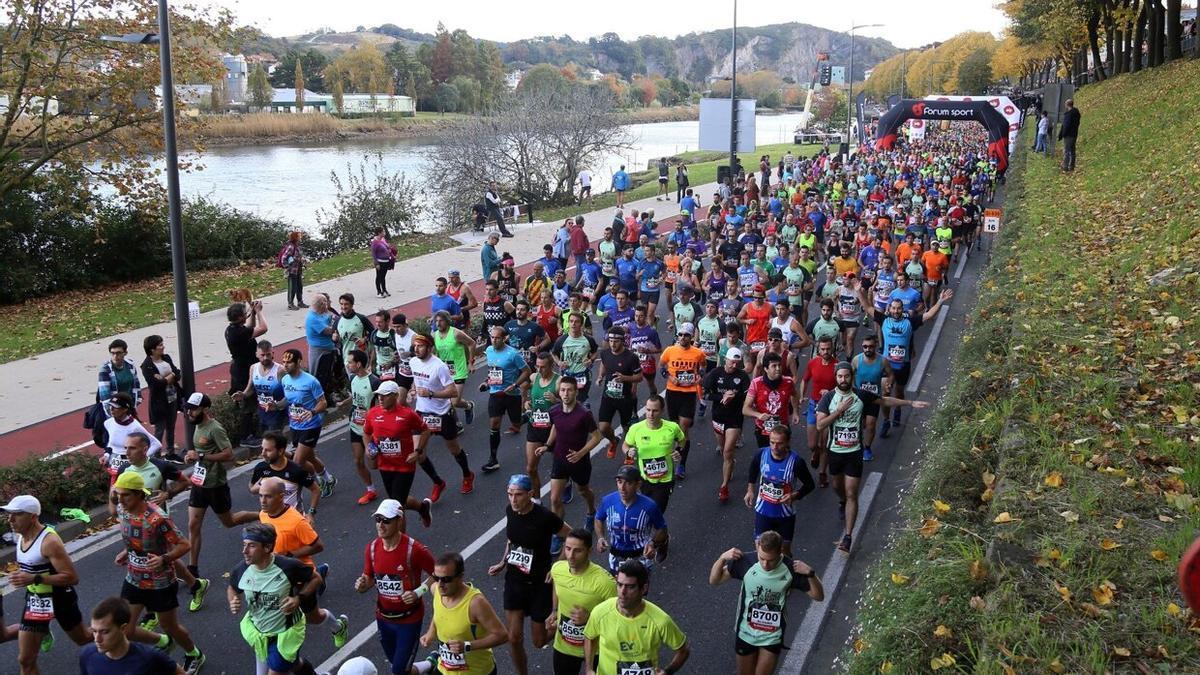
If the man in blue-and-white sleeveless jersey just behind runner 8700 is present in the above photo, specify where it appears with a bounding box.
[745,426,817,556]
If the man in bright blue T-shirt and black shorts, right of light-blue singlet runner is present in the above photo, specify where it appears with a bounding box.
[276,350,337,497]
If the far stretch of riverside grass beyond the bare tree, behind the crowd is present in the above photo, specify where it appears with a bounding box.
[534,143,821,222]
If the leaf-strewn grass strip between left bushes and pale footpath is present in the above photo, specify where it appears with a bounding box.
[0,235,456,363]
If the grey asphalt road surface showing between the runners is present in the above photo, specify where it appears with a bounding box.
[0,222,984,674]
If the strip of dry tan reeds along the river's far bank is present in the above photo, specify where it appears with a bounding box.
[192,106,700,148]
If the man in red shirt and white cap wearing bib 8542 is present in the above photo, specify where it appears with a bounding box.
[354,497,434,673]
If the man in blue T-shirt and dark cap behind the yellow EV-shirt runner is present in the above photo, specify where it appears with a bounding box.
[595,464,667,574]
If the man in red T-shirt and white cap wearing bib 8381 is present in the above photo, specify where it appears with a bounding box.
[362,380,433,527]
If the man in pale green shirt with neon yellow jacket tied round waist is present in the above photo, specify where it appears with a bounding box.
[227,522,322,673]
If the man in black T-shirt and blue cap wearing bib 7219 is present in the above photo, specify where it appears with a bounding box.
[487,470,571,673]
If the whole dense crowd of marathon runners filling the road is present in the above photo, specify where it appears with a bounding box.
[0,120,998,675]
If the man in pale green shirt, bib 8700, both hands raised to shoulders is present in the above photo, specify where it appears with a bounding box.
[708,530,824,673]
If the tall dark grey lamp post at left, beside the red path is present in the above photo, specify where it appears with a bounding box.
[101,0,196,449]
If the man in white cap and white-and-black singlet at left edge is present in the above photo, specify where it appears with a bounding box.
[0,487,91,673]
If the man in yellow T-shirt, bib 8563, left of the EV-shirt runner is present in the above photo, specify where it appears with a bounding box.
[546,528,617,673]
